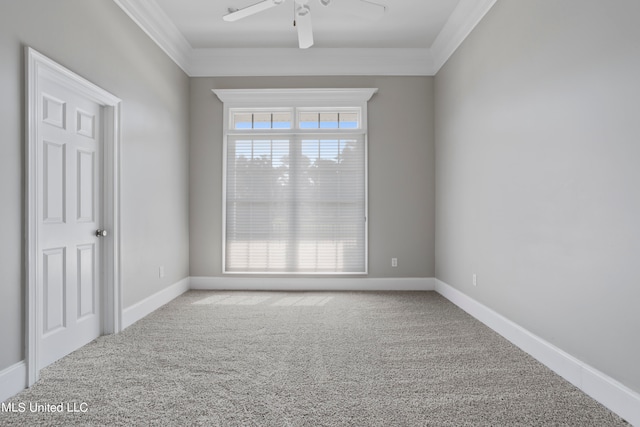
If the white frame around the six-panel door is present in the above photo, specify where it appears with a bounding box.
[25,46,122,387]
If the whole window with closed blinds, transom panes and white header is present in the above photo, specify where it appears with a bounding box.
[215,89,375,274]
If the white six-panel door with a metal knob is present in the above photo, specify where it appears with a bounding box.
[36,76,103,368]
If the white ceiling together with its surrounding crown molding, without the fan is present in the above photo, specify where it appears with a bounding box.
[113,0,496,76]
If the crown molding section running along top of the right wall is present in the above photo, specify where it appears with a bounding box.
[431,0,497,74]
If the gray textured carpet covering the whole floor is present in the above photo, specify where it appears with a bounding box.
[0,291,628,427]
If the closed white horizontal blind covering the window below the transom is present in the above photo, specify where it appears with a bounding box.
[225,132,366,273]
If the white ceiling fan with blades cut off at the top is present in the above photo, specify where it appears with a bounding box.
[222,0,387,49]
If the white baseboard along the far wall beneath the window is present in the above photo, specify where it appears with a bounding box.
[191,276,435,291]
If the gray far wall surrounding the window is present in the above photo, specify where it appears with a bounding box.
[190,77,435,277]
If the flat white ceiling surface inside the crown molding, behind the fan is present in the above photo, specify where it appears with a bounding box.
[155,0,458,48]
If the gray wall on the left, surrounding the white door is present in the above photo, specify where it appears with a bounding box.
[0,0,189,370]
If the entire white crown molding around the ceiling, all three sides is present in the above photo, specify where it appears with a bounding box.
[113,0,496,77]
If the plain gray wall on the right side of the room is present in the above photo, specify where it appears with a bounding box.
[435,0,640,391]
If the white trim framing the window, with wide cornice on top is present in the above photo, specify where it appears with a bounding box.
[212,88,378,276]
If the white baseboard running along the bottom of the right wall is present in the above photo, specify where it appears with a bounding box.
[434,279,640,426]
